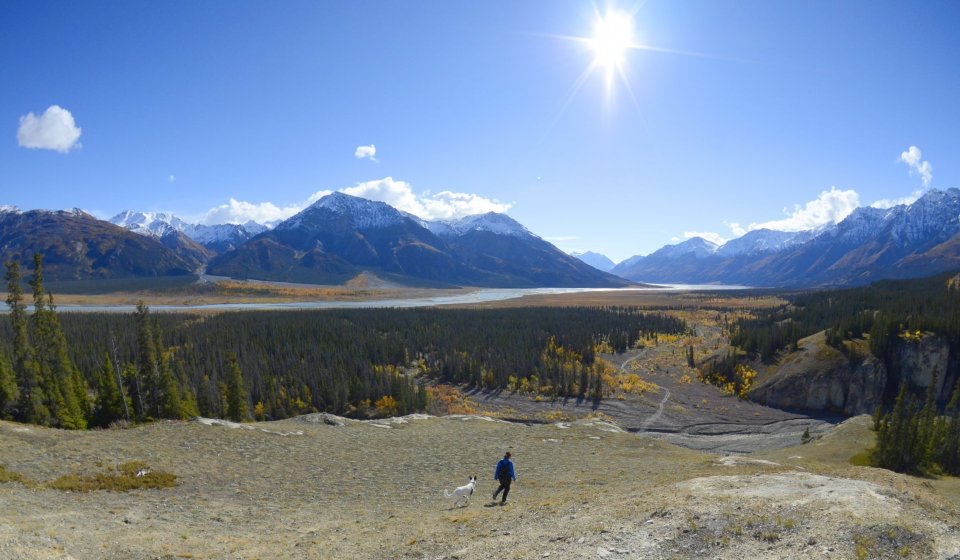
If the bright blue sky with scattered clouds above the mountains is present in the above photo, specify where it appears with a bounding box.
[0,0,960,260]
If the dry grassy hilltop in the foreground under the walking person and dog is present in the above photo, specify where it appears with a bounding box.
[0,415,960,559]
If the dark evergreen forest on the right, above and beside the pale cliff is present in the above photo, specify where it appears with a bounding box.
[720,274,960,475]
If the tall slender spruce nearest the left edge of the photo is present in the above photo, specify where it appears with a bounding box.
[4,261,51,425]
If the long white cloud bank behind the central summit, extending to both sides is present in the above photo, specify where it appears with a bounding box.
[199,177,511,224]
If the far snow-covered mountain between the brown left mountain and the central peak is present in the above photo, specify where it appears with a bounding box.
[110,210,268,256]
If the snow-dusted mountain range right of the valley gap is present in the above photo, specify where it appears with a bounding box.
[613,189,960,286]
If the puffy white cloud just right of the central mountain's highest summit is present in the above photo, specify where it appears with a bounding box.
[340,177,511,220]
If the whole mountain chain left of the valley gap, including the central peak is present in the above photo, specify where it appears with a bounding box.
[0,193,633,287]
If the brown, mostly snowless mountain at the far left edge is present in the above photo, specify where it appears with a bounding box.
[0,207,195,280]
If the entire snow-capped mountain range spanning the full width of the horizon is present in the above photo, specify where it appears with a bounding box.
[0,189,960,287]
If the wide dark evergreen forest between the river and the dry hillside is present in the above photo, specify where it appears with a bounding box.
[0,257,686,429]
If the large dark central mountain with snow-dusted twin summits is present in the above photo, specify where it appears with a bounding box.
[208,193,626,287]
